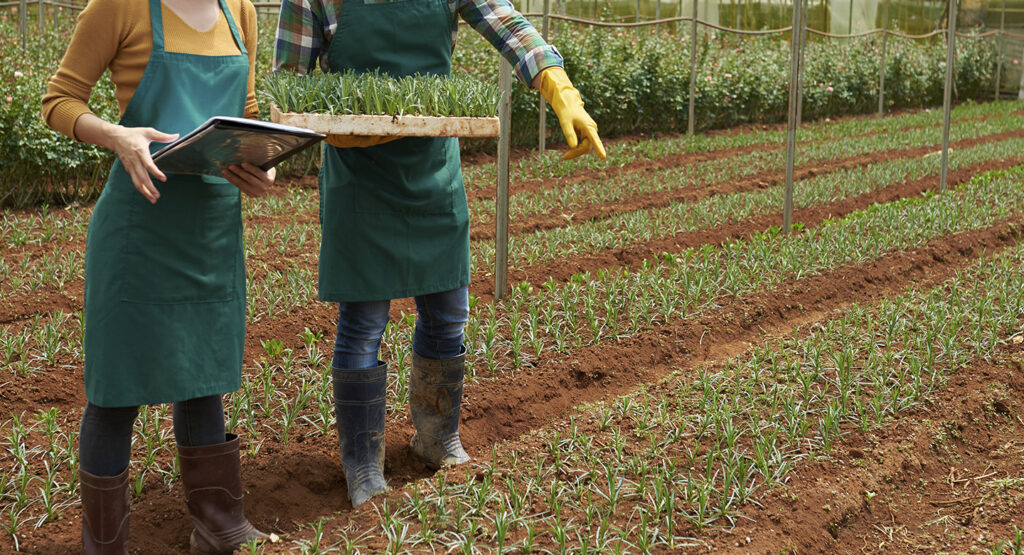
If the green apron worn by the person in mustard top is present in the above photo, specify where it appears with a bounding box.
[85,0,249,407]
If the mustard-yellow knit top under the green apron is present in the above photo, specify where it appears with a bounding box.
[43,0,257,140]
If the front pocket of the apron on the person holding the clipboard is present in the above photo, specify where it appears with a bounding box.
[121,187,242,303]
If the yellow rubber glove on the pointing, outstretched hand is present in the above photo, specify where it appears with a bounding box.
[538,66,607,160]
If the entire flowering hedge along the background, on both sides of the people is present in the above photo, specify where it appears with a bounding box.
[0,11,995,206]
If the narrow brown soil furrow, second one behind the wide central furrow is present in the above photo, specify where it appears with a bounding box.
[470,129,1024,241]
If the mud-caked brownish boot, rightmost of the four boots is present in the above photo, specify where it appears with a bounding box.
[409,349,469,468]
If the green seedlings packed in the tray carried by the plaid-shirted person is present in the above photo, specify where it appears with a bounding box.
[262,72,499,118]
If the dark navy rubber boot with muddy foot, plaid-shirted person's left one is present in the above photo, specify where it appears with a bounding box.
[332,362,387,507]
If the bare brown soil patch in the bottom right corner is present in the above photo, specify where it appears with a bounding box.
[712,344,1024,554]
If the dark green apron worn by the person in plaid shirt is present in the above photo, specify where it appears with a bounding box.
[319,0,469,302]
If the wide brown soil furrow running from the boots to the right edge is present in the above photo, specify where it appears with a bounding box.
[7,217,1024,553]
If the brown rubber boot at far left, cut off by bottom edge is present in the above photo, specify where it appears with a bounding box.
[78,468,131,555]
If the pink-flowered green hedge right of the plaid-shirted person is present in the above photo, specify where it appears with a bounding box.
[455,26,995,143]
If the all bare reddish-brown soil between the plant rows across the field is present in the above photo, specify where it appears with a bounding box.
[0,106,1024,554]
